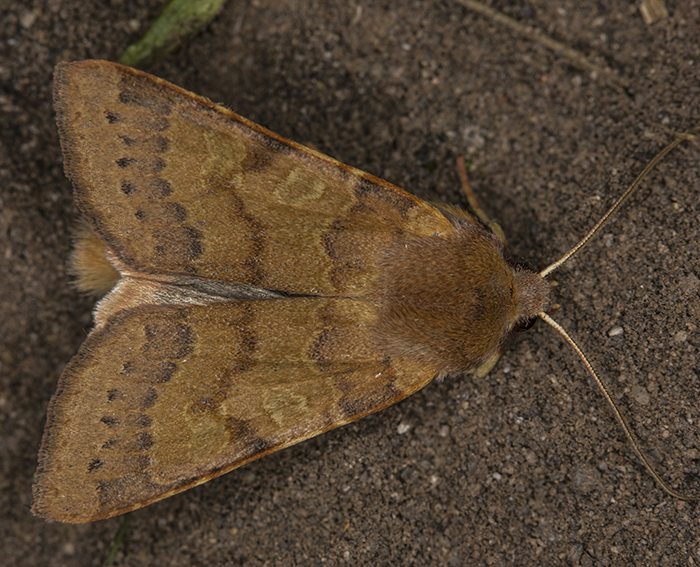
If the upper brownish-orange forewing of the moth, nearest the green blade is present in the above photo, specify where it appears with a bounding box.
[55,61,453,295]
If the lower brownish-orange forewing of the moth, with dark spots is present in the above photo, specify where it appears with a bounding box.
[33,298,435,522]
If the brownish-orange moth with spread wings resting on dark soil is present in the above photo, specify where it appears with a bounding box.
[33,61,696,522]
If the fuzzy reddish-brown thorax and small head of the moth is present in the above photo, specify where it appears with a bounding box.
[378,222,546,378]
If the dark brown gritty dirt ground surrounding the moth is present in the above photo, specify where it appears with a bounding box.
[0,0,700,566]
